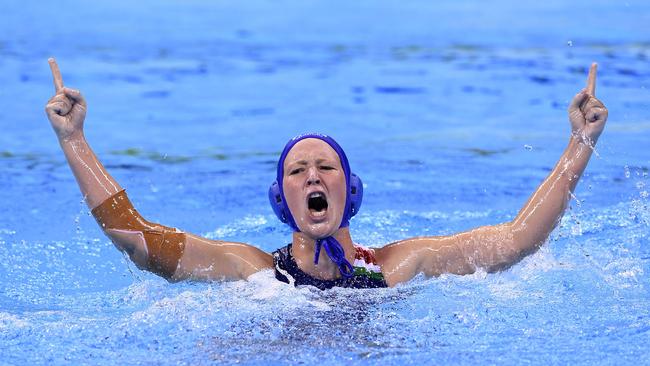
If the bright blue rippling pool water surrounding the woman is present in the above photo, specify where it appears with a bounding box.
[0,0,650,365]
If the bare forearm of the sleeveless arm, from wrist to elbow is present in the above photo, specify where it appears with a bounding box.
[511,136,593,255]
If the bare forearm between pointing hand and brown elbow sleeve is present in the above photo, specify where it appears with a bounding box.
[59,133,122,209]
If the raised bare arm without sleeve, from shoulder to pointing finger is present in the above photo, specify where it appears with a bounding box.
[377,64,607,285]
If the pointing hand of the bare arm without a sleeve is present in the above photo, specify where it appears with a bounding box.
[569,63,607,145]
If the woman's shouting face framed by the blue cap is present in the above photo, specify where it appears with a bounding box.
[282,138,346,239]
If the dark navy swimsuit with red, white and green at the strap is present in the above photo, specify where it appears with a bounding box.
[273,244,388,290]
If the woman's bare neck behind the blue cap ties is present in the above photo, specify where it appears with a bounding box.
[291,227,355,280]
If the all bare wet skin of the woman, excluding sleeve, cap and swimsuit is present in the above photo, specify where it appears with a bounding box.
[45,59,608,286]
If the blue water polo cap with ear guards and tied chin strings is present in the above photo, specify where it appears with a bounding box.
[269,133,363,277]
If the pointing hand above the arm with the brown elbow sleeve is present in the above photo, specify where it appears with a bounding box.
[45,58,86,141]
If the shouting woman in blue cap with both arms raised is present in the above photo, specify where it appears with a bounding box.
[45,59,607,289]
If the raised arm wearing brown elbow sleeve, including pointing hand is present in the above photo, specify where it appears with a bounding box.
[45,59,273,281]
